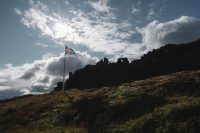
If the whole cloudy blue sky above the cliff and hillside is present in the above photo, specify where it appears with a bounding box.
[0,0,200,99]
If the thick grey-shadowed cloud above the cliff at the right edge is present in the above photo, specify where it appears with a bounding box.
[137,16,200,50]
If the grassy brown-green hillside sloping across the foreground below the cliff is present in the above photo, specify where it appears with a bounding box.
[0,71,200,133]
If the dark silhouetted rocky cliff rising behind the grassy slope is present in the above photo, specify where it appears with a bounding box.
[65,40,200,89]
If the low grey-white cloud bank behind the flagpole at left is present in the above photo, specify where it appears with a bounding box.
[0,51,97,99]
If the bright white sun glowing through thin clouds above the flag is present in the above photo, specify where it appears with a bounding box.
[53,22,74,38]
